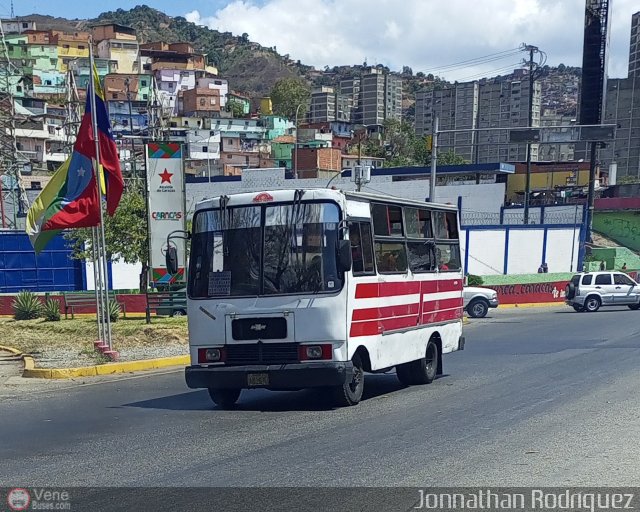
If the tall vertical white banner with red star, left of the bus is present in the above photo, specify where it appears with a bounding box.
[147,142,186,286]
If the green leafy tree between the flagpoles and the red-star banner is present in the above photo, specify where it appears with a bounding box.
[64,184,149,291]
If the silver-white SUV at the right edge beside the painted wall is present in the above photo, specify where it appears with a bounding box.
[565,272,640,313]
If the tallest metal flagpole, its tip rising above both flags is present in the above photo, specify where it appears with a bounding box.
[89,40,113,351]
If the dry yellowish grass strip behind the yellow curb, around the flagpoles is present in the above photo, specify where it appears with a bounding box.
[0,317,187,353]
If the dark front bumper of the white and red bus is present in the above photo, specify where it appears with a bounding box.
[185,361,353,390]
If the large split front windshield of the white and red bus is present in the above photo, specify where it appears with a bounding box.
[189,202,343,298]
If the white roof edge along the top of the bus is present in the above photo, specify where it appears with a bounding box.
[195,188,457,211]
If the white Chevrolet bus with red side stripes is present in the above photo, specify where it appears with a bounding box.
[167,189,464,408]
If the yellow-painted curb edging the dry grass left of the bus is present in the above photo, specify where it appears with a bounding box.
[0,345,191,379]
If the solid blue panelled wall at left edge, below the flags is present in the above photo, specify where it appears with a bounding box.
[0,231,86,293]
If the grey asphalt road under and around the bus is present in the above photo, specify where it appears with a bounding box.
[0,307,640,496]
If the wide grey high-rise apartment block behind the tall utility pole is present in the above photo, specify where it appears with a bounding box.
[416,80,541,163]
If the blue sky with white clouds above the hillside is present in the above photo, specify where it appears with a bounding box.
[8,0,640,81]
